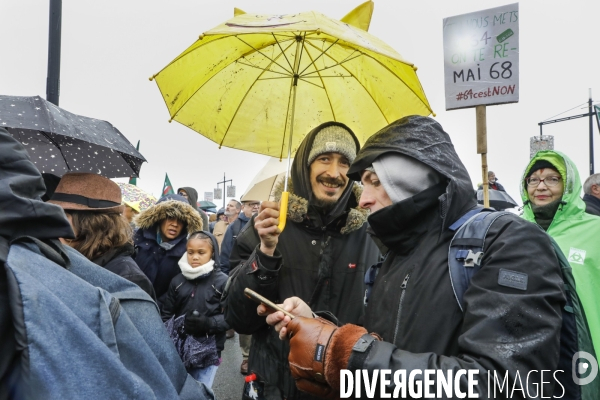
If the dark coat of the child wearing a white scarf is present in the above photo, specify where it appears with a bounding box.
[161,234,229,357]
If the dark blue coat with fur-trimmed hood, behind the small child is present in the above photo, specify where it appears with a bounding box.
[133,196,202,306]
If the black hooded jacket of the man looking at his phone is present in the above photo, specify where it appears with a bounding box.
[348,117,570,398]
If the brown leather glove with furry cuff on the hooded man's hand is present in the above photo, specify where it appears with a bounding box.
[287,317,367,399]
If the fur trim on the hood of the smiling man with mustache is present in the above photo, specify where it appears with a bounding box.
[273,179,369,235]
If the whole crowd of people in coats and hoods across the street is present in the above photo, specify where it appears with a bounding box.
[0,116,600,400]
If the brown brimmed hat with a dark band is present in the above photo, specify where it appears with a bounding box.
[49,172,123,213]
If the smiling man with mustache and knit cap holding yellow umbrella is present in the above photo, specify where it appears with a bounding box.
[224,122,379,400]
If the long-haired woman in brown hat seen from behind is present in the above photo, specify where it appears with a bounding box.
[49,172,156,299]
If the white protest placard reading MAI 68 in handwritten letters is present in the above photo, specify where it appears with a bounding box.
[444,3,519,110]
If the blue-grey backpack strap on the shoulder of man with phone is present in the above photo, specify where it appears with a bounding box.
[448,207,510,311]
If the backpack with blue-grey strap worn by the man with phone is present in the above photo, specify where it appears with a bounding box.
[448,207,600,400]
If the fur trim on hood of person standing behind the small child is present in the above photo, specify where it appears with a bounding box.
[134,200,202,233]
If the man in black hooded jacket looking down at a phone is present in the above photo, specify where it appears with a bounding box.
[266,115,568,399]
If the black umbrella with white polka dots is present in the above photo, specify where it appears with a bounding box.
[0,95,146,178]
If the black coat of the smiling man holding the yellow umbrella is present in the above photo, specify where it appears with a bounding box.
[225,121,379,399]
